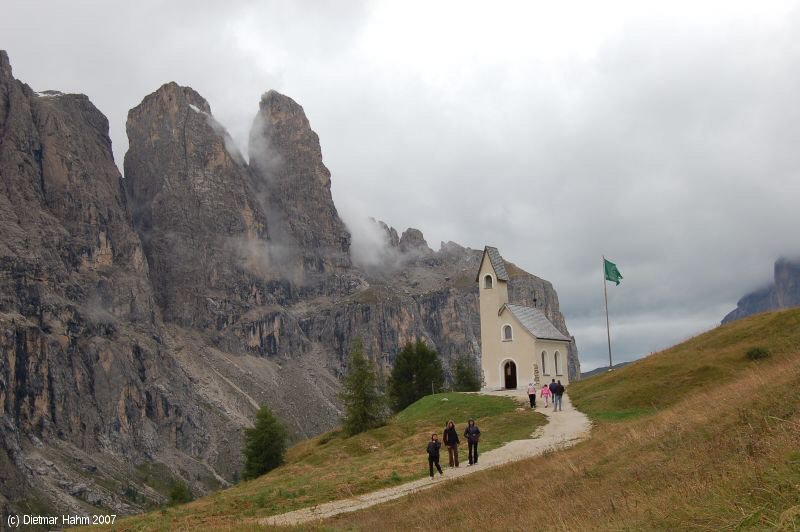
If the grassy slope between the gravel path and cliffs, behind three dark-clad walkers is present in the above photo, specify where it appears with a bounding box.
[94,393,544,530]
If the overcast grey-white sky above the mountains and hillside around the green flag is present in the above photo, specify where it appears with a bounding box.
[0,0,800,370]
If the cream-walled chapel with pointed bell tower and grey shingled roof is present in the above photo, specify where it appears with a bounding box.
[476,246,570,390]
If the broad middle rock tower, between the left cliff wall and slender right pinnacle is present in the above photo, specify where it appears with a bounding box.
[125,83,269,328]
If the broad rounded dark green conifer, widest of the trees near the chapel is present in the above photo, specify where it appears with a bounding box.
[389,340,444,412]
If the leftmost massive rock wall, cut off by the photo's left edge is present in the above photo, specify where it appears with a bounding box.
[0,52,225,513]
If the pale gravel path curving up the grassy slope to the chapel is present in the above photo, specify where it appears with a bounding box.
[259,392,591,525]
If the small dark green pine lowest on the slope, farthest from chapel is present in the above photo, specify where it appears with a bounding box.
[242,406,287,480]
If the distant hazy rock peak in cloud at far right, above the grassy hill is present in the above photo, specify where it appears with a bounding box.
[722,258,800,323]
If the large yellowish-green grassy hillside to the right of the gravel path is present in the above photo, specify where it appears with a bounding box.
[324,309,800,531]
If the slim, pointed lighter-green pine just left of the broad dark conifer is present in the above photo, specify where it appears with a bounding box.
[342,340,386,436]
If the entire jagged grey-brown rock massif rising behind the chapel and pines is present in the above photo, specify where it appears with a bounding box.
[0,53,579,513]
